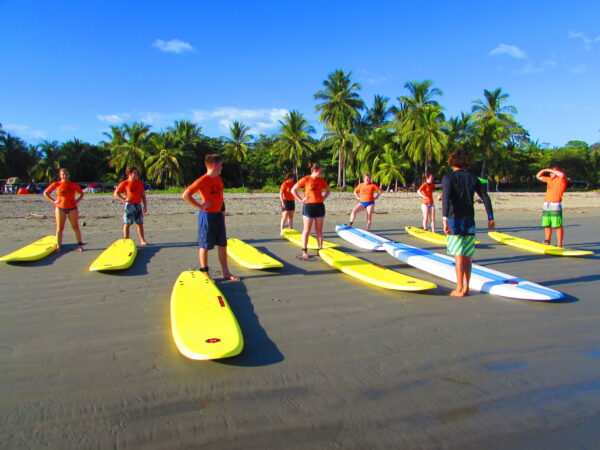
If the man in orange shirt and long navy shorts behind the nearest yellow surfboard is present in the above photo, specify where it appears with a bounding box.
[181,154,239,280]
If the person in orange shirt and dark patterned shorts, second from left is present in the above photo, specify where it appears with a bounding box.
[113,167,148,245]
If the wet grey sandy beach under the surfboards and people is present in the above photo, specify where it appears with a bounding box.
[0,192,600,449]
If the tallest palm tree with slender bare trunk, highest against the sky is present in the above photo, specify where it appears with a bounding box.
[314,69,365,187]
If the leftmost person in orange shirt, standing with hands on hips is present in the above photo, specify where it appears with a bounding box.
[44,169,83,252]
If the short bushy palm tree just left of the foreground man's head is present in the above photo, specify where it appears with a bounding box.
[145,132,185,186]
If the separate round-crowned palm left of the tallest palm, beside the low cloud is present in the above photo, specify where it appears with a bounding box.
[275,111,315,179]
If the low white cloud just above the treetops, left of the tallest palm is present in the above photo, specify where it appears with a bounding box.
[193,107,288,134]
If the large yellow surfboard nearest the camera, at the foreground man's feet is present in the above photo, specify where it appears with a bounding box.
[171,270,244,360]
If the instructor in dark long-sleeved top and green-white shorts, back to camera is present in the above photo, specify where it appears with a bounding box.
[442,151,496,297]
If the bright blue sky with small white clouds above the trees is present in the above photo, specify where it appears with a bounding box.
[0,0,600,146]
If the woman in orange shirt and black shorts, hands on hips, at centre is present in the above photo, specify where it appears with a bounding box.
[291,163,331,259]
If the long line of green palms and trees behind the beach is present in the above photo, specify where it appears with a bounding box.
[0,70,600,190]
